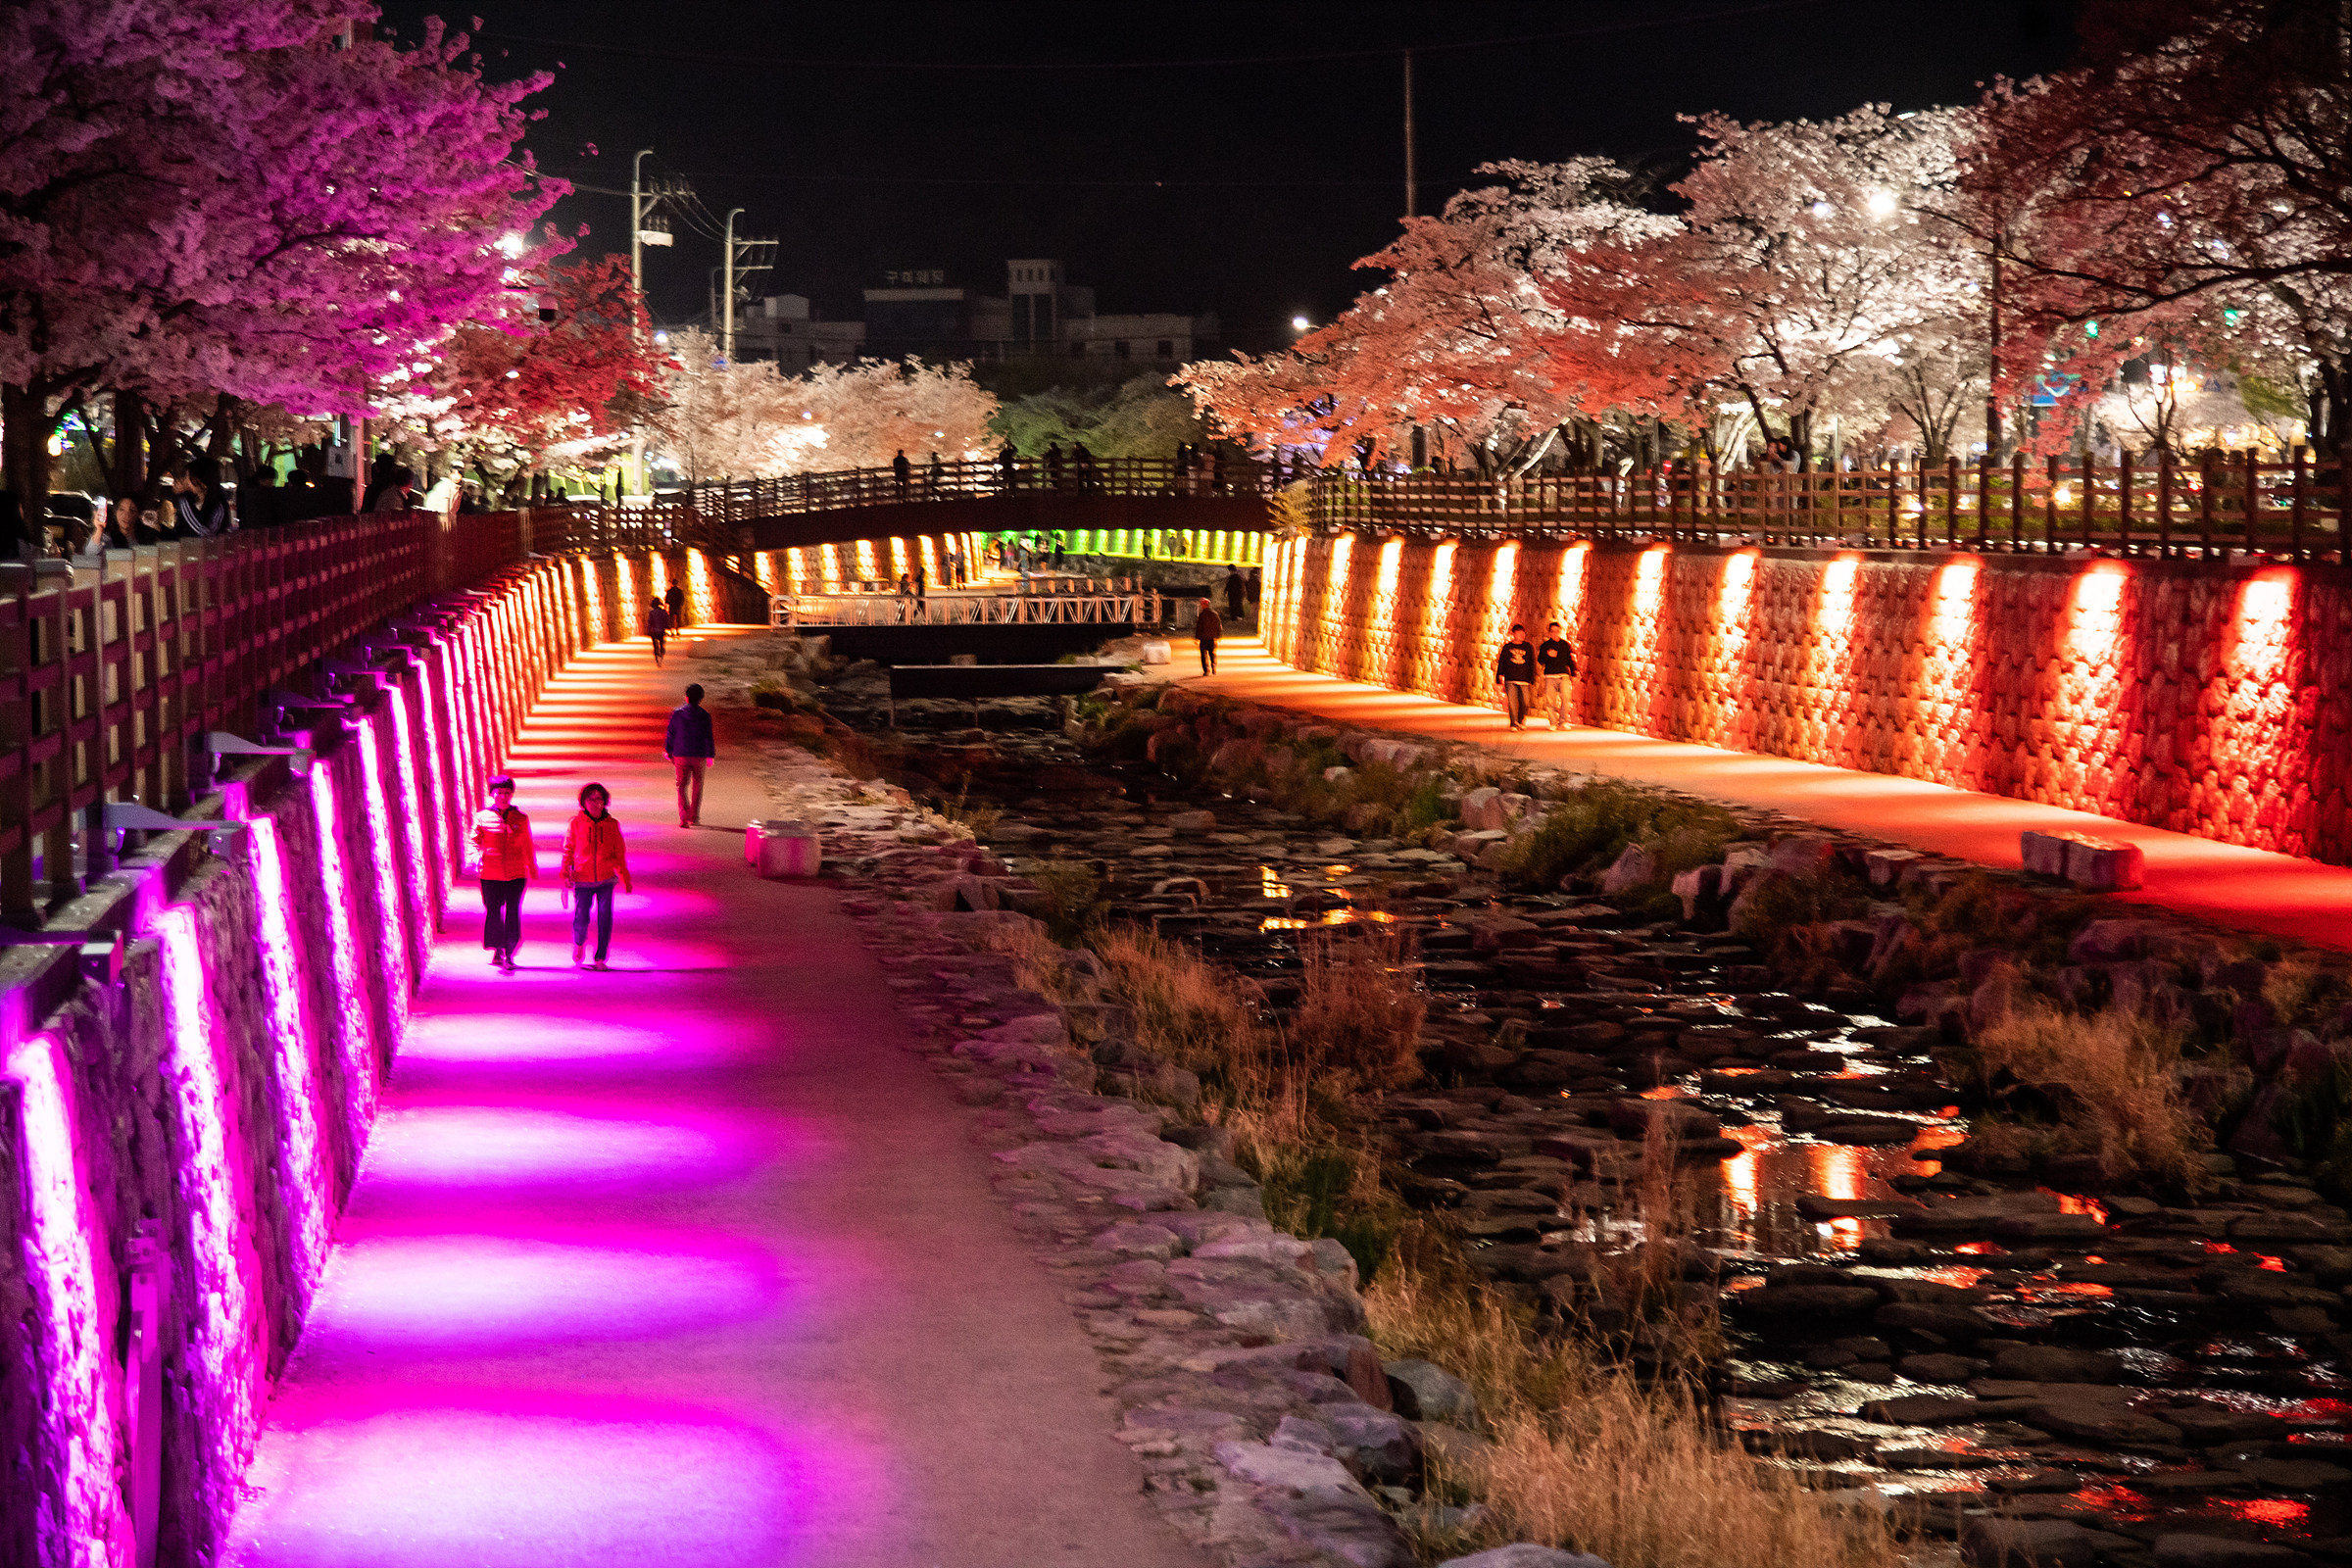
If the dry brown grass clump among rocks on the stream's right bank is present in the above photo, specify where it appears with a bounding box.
[1971,997,2211,1185]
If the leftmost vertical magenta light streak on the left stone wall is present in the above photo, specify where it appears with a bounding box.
[7,1034,131,1568]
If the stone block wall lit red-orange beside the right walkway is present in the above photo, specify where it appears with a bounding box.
[1263,534,2352,865]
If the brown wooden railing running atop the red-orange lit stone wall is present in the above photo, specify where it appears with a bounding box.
[1307,454,2352,562]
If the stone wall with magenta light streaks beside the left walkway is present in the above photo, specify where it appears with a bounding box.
[0,550,741,1568]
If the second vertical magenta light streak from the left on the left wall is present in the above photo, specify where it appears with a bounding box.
[155,906,269,1474]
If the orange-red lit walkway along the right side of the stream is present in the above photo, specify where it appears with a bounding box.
[1203,637,2352,950]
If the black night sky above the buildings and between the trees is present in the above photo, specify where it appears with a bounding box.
[371,0,2072,348]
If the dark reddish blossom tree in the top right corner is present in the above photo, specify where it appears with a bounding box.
[1962,0,2352,463]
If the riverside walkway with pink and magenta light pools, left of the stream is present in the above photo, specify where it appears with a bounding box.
[225,629,1198,1568]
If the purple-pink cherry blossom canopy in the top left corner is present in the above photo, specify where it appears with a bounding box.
[0,0,563,506]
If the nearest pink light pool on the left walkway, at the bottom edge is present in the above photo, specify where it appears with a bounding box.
[229,1382,851,1568]
